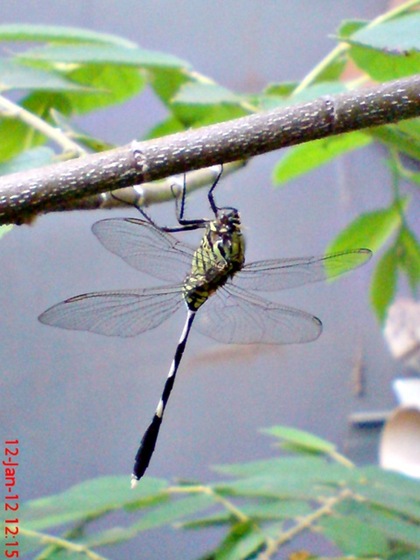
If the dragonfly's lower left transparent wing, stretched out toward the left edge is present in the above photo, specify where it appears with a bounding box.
[39,285,183,337]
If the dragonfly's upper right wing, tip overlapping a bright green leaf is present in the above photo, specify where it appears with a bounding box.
[232,249,372,292]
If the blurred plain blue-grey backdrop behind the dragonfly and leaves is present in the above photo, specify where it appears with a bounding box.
[0,0,416,560]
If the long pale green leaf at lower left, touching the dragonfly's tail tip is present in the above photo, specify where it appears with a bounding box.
[20,476,166,530]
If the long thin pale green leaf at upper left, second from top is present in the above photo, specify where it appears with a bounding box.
[18,44,189,68]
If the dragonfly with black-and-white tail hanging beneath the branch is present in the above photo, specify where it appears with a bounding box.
[39,170,372,488]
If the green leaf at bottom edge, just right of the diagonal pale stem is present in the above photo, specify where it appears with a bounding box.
[320,516,389,557]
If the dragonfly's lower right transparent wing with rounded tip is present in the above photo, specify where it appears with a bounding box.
[194,285,322,344]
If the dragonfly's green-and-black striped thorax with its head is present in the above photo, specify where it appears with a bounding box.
[183,207,245,311]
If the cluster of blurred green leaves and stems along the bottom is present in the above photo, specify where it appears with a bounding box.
[13,426,420,560]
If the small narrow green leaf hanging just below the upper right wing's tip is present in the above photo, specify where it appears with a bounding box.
[370,246,398,324]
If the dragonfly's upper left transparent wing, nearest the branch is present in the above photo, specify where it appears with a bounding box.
[92,218,194,282]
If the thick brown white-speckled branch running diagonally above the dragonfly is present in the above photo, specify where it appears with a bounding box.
[0,75,420,224]
